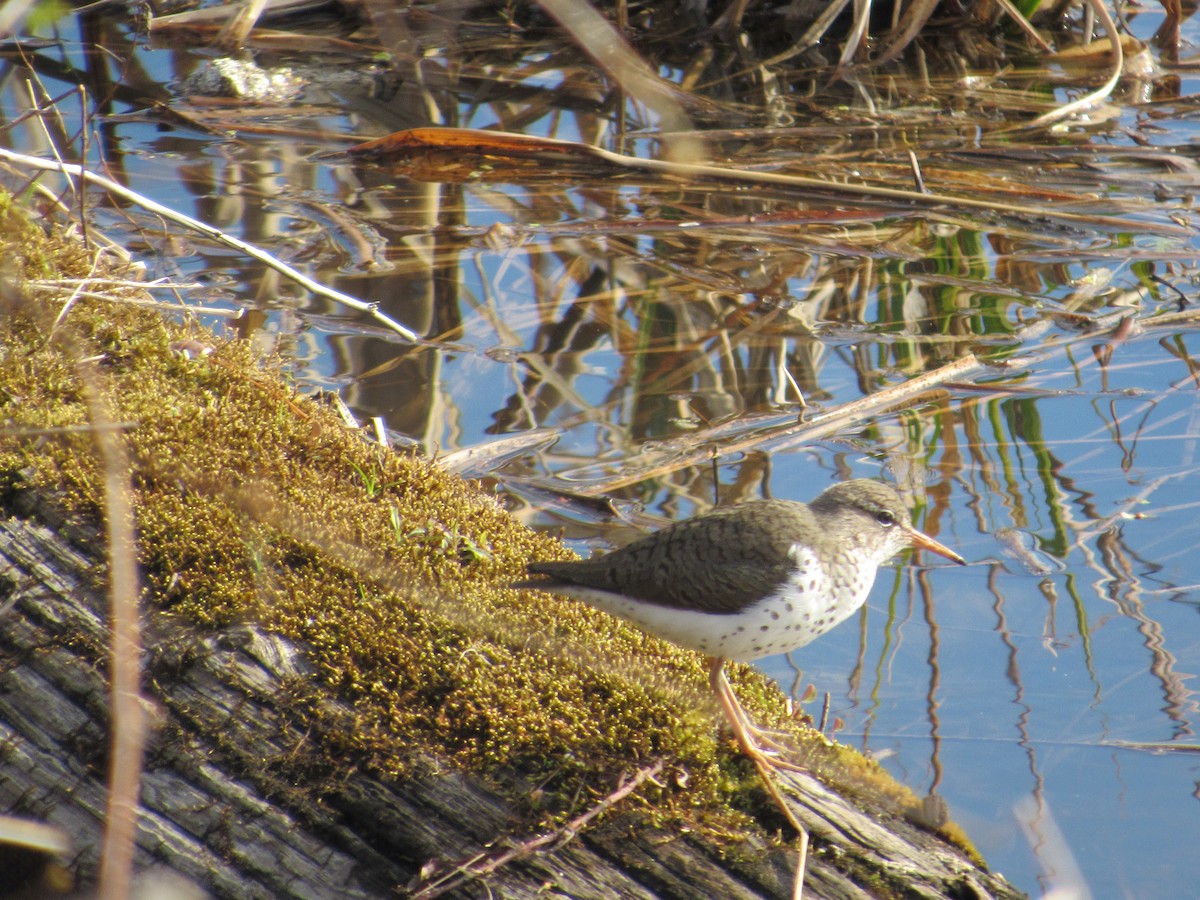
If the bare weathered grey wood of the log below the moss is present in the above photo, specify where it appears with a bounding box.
[0,508,1019,898]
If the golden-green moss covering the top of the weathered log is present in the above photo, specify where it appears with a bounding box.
[0,192,974,873]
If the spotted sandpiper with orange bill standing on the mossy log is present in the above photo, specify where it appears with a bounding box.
[517,479,965,766]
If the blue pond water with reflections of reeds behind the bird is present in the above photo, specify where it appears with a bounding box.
[7,5,1200,896]
